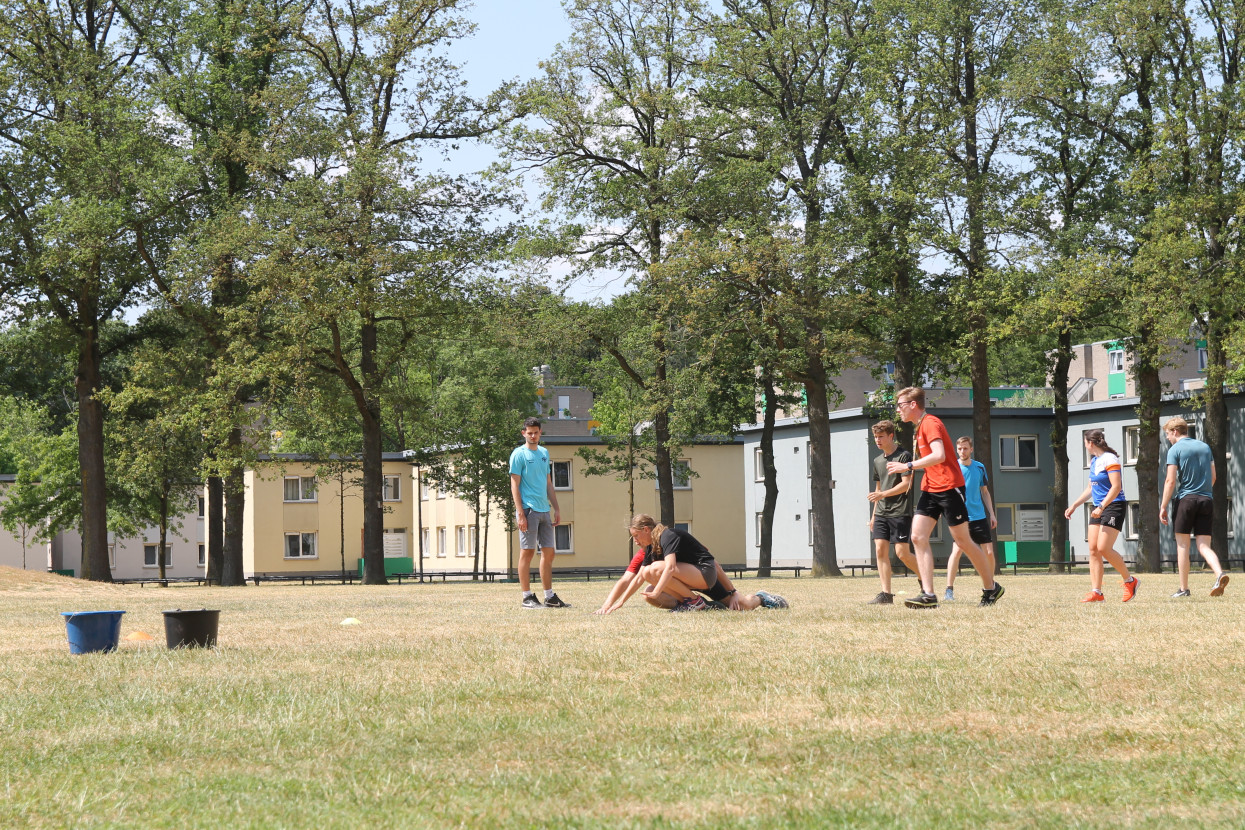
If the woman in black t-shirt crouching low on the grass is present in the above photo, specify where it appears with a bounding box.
[629,513,787,611]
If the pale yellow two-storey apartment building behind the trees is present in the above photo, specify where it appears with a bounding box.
[243,436,746,576]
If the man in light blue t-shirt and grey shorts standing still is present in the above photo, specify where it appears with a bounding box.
[510,418,570,609]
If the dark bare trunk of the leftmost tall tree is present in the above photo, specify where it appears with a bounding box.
[73,321,112,582]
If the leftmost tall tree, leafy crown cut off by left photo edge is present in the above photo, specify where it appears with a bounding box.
[0,0,183,581]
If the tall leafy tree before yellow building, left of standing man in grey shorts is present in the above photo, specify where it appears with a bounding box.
[255,0,504,584]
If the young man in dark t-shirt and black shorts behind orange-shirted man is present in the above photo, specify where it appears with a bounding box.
[869,421,916,605]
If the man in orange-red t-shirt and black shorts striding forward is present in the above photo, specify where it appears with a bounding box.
[886,386,1003,609]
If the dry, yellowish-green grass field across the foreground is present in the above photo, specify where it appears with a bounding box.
[0,569,1245,829]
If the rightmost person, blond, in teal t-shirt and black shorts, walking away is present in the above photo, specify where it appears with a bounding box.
[1159,416,1228,597]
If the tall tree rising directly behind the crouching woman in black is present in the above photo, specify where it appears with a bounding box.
[505,0,700,525]
